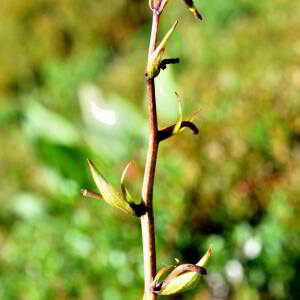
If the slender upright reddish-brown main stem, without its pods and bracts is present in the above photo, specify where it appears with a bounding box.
[141,13,159,300]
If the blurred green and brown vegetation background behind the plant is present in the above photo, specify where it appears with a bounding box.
[0,0,300,300]
